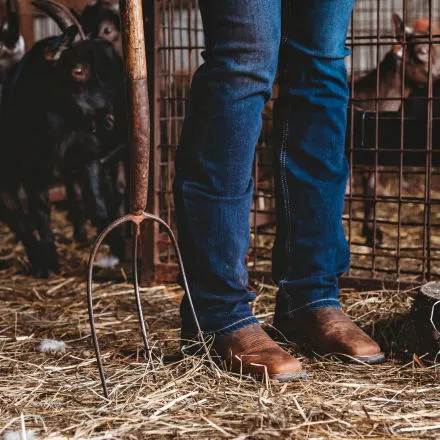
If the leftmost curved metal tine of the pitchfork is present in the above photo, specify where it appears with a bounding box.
[87,214,132,399]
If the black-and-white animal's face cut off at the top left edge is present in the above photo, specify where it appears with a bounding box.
[0,0,25,83]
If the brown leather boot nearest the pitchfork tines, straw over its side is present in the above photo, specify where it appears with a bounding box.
[194,324,306,382]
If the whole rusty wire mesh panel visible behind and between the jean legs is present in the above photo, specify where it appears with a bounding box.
[155,0,440,281]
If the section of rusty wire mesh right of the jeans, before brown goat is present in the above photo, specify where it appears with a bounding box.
[344,0,440,280]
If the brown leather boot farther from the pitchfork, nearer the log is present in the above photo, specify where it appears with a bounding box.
[274,307,386,365]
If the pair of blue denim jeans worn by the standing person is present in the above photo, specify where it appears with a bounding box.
[174,0,354,335]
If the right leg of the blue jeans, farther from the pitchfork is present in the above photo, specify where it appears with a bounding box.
[273,0,353,316]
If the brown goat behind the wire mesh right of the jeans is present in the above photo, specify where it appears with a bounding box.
[347,14,440,245]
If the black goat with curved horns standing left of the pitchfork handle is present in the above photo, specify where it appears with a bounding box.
[0,0,126,276]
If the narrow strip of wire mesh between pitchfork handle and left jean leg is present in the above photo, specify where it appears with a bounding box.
[154,0,204,275]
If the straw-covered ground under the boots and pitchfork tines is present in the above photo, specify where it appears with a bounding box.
[0,211,440,440]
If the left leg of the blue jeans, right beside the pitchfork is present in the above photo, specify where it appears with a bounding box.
[173,0,281,336]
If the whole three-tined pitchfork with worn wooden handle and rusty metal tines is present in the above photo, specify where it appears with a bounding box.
[87,0,211,399]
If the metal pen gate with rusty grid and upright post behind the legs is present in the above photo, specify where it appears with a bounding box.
[143,0,440,283]
